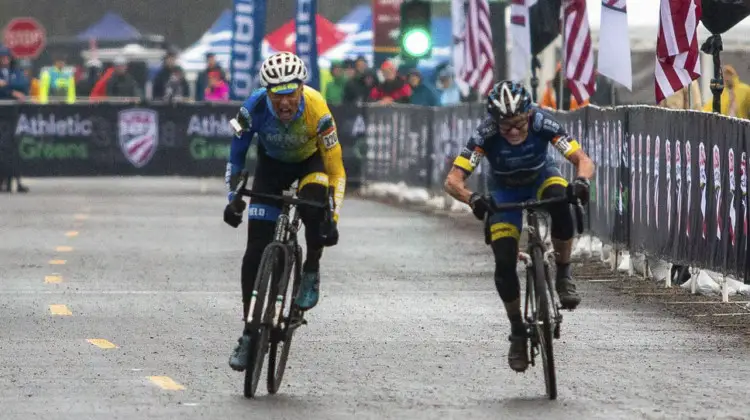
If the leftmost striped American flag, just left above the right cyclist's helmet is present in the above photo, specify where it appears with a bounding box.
[453,0,495,95]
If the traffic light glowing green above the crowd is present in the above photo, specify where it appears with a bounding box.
[399,0,432,59]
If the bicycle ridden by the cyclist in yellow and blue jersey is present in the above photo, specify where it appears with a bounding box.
[232,171,333,398]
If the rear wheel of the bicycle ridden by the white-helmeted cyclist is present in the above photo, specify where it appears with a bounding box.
[266,245,302,394]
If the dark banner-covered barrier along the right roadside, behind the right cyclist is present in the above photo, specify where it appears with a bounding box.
[358,105,750,278]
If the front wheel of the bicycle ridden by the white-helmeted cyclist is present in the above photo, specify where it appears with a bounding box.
[244,243,284,398]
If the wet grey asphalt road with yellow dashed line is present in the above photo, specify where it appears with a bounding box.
[0,178,750,419]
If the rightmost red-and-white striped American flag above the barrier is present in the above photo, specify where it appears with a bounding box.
[654,0,701,103]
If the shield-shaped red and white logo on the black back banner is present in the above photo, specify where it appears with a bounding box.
[118,108,159,168]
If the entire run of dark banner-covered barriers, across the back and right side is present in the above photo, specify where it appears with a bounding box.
[0,102,750,279]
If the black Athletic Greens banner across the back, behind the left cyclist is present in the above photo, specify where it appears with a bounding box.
[0,103,367,180]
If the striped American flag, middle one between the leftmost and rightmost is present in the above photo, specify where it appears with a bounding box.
[563,0,596,104]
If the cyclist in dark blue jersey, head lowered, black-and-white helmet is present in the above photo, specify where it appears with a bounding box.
[445,80,594,372]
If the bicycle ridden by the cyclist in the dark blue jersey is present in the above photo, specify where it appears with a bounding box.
[484,197,583,400]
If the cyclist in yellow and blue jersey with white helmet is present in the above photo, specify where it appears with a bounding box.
[224,52,346,371]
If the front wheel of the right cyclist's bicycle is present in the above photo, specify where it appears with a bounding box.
[531,246,557,400]
